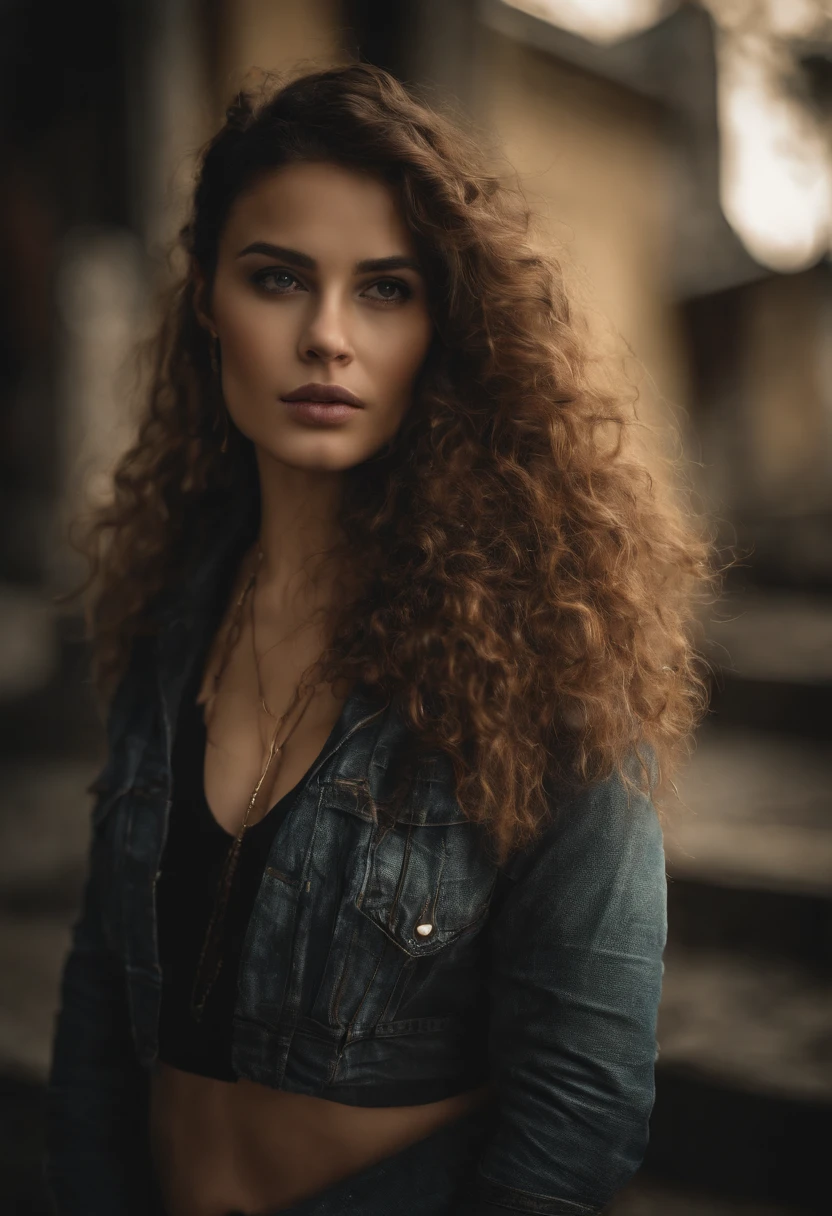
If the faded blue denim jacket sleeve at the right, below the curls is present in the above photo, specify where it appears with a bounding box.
[471,749,667,1216]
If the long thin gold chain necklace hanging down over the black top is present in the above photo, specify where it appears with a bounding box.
[191,545,320,1021]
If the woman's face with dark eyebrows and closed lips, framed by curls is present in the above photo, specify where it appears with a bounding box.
[201,163,432,471]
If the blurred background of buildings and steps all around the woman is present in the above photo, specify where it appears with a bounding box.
[0,0,832,1216]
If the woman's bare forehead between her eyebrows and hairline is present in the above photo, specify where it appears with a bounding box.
[220,162,414,261]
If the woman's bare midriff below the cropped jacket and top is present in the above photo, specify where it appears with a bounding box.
[150,1064,489,1216]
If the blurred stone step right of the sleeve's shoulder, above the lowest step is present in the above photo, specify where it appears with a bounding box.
[664,724,832,966]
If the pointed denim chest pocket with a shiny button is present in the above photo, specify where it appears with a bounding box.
[356,803,496,958]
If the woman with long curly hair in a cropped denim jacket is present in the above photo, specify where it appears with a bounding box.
[49,64,714,1216]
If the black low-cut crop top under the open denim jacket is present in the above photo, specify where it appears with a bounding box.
[156,627,303,1081]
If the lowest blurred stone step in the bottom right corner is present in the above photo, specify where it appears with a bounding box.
[642,947,832,1216]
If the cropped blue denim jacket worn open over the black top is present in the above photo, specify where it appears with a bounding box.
[47,496,667,1216]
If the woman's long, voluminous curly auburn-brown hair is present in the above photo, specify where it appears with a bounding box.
[61,63,721,858]
